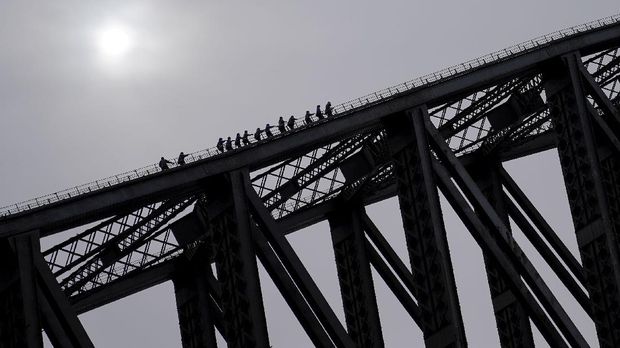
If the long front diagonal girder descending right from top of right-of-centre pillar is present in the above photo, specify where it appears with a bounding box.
[425,113,587,347]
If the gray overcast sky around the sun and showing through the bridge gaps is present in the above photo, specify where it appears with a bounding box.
[0,0,620,347]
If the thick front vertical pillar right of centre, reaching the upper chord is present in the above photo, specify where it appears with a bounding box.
[386,107,467,347]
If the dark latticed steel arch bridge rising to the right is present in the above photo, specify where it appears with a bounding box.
[0,12,620,348]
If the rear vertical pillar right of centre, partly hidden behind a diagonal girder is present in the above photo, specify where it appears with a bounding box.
[470,159,534,347]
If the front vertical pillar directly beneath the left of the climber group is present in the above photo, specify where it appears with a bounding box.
[207,172,269,348]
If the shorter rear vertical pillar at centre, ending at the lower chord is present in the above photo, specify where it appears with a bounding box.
[328,206,384,347]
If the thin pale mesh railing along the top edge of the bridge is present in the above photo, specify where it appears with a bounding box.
[0,14,620,219]
